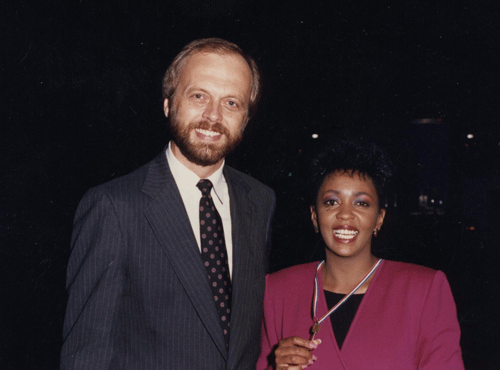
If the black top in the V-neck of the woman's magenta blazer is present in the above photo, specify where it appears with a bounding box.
[324,290,364,349]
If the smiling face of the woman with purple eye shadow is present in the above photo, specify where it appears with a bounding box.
[311,172,385,258]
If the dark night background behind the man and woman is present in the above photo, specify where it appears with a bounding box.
[0,0,500,369]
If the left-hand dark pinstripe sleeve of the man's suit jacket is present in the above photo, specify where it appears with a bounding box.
[61,189,126,370]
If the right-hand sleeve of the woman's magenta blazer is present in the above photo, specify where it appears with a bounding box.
[418,271,464,370]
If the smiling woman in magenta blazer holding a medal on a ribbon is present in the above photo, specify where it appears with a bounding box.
[257,141,463,370]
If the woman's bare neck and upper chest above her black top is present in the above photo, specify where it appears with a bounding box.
[321,254,378,294]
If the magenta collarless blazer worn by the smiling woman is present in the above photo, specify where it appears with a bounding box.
[257,261,464,370]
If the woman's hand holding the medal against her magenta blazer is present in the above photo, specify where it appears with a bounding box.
[274,337,321,370]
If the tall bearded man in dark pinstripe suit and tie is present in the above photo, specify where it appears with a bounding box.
[61,39,275,370]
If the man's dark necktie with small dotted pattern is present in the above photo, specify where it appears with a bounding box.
[196,179,232,345]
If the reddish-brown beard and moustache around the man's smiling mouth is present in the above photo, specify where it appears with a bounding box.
[170,111,243,167]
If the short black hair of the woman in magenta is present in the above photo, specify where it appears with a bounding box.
[309,140,393,208]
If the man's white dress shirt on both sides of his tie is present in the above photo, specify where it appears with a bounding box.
[166,142,233,276]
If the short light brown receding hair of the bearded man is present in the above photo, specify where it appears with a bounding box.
[162,38,261,117]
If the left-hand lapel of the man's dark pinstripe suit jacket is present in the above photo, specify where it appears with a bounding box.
[143,152,227,360]
